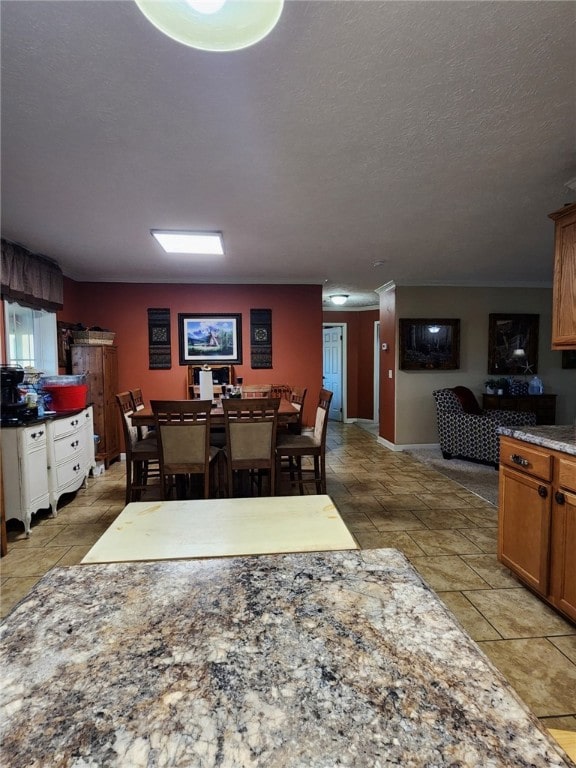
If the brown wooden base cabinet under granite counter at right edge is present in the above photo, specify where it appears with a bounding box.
[498,437,576,621]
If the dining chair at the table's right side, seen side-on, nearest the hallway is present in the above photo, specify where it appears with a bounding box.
[276,389,333,495]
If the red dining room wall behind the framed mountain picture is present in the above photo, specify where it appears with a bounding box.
[58,279,322,424]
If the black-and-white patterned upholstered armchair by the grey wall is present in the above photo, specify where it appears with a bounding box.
[432,387,536,468]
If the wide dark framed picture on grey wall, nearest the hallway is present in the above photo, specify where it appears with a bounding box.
[399,318,460,371]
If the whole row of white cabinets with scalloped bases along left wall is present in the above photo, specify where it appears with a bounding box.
[0,406,96,536]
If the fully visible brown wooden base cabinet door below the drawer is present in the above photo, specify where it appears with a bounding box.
[498,466,552,596]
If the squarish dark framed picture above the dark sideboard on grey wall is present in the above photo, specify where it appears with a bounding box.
[488,313,540,376]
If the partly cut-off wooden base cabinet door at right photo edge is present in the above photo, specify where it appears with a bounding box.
[551,491,576,621]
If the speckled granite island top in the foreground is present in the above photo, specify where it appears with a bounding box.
[0,549,570,768]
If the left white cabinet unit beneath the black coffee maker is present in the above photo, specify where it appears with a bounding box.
[1,424,50,536]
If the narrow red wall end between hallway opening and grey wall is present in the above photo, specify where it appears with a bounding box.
[380,289,396,443]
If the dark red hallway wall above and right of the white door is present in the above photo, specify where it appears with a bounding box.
[324,309,379,419]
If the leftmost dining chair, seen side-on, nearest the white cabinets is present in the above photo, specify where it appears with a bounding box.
[116,392,159,504]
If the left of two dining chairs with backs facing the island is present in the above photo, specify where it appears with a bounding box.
[150,400,220,499]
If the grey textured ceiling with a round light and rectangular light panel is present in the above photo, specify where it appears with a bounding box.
[1,0,576,306]
